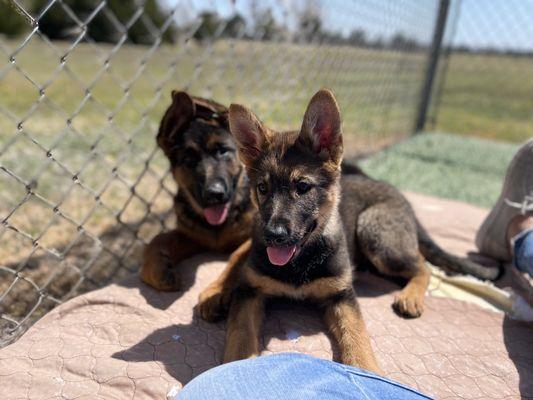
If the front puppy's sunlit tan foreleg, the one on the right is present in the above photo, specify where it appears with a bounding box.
[324,289,382,374]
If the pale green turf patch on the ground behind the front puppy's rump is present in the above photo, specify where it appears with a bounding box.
[363,133,518,207]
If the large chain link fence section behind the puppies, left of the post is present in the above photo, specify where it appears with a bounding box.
[0,0,439,345]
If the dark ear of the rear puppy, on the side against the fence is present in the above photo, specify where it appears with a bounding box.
[157,90,196,155]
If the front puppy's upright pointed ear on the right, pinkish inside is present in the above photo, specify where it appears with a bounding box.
[299,89,342,164]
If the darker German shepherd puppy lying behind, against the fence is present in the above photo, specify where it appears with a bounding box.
[140,91,255,291]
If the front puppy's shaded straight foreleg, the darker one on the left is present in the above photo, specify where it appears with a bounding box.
[224,288,264,363]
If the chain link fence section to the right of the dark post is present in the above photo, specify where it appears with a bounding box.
[426,0,533,142]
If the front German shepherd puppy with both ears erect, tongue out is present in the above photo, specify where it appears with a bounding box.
[198,90,498,371]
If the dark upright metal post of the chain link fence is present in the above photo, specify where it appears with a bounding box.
[415,0,450,133]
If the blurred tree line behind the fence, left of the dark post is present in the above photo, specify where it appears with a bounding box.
[0,0,424,51]
